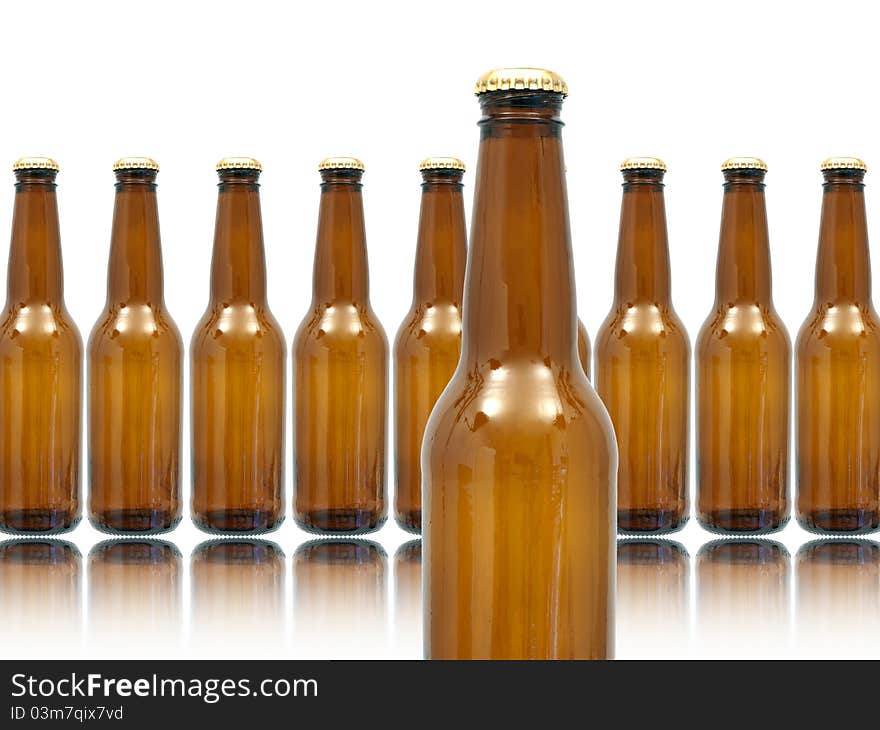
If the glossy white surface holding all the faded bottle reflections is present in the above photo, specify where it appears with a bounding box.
[0,523,880,659]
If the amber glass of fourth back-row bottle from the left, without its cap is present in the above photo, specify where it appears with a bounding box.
[293,169,388,534]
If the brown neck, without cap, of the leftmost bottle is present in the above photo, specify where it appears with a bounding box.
[6,170,64,307]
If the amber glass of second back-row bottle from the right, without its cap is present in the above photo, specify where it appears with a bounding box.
[696,169,791,533]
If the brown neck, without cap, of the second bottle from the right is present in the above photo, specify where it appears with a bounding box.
[715,170,772,306]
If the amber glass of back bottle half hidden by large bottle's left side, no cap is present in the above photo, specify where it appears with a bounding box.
[394,169,467,533]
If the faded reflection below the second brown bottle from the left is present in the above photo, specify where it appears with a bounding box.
[89,539,183,656]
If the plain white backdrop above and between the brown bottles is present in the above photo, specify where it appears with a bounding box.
[0,0,880,656]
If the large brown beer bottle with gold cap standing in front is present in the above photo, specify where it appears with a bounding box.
[422,69,617,659]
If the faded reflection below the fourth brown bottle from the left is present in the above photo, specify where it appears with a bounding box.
[293,539,387,659]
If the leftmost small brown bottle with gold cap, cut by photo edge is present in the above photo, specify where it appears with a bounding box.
[0,157,82,533]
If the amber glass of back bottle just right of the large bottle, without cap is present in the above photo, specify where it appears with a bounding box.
[596,169,690,533]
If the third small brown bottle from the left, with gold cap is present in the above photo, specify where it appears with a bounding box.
[190,157,286,533]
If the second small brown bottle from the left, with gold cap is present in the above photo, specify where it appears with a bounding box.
[88,157,183,533]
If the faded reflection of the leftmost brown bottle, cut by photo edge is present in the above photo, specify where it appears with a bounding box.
[0,538,82,659]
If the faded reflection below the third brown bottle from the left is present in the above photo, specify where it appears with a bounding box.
[190,539,286,658]
